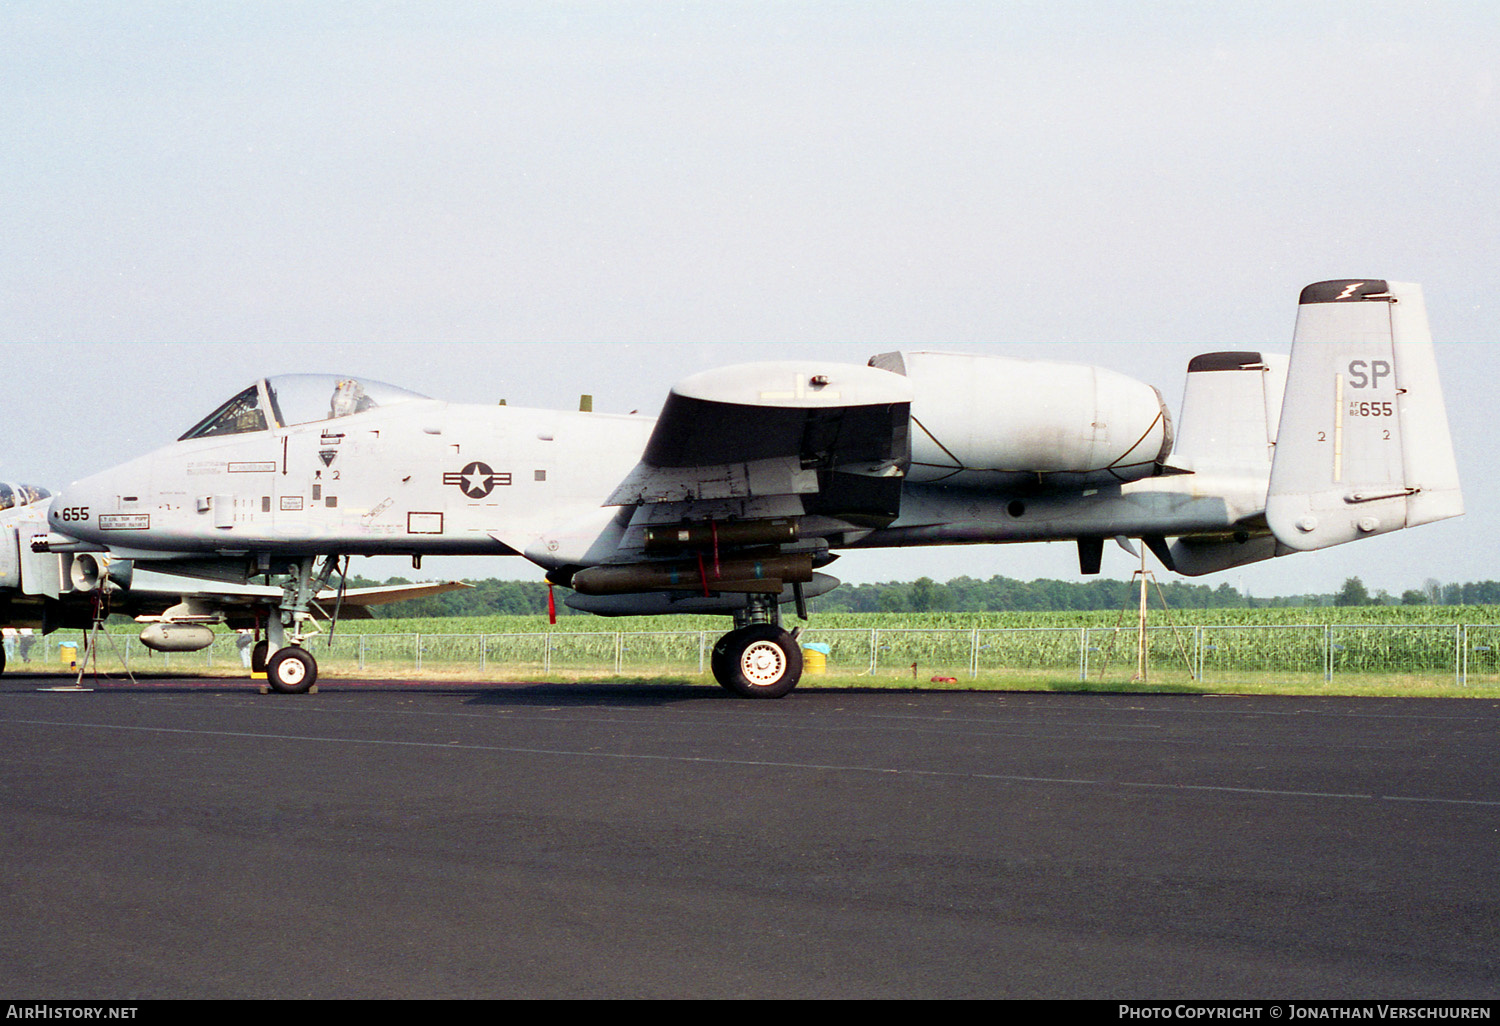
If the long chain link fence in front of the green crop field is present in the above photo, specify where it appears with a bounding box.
[32,624,1500,686]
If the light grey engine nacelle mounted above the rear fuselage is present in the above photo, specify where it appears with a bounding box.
[870,353,1172,491]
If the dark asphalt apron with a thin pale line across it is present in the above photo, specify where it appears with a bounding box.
[0,675,1500,999]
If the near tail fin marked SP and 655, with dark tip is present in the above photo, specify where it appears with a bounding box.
[1266,279,1464,551]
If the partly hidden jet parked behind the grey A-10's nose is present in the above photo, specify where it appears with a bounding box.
[0,492,468,674]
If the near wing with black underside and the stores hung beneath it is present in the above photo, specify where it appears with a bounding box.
[552,360,912,612]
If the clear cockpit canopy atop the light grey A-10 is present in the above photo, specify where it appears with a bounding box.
[177,374,428,441]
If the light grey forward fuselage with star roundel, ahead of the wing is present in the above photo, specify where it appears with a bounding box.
[50,399,653,555]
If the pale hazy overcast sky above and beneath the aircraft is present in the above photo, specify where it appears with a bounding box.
[0,0,1500,594]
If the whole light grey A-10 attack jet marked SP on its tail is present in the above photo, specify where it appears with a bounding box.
[35,281,1463,698]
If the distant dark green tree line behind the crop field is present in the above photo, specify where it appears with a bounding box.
[348,576,1500,618]
